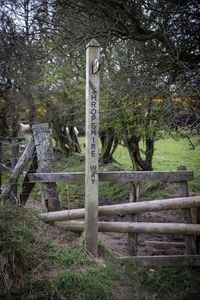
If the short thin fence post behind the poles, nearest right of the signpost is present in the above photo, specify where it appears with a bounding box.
[128,182,140,256]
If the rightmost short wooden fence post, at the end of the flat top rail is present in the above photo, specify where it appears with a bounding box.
[177,166,197,254]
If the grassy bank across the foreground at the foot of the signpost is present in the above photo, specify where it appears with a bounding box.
[0,206,200,300]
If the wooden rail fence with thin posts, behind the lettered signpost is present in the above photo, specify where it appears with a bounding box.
[29,154,200,266]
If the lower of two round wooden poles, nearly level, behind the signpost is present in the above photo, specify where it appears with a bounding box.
[55,221,200,235]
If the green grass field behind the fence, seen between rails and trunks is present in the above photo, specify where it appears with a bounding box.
[3,137,200,208]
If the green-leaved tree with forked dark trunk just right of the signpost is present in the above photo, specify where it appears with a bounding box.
[102,41,168,170]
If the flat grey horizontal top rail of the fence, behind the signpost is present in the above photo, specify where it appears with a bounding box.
[29,171,193,182]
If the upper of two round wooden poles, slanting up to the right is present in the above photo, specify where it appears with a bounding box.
[40,196,200,223]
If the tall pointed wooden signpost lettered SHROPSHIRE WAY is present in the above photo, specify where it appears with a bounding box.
[85,39,100,256]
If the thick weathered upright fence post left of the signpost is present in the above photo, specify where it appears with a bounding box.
[32,123,61,211]
